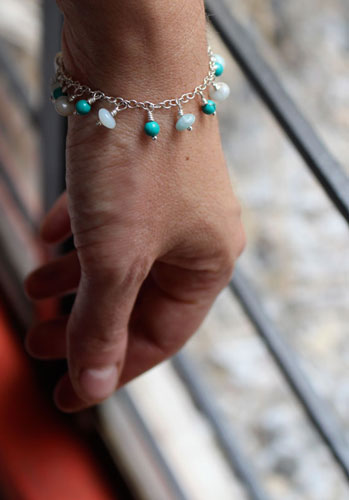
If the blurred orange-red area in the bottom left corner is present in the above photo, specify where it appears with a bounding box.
[0,304,116,500]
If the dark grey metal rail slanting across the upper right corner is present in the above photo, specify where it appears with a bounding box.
[205,0,349,223]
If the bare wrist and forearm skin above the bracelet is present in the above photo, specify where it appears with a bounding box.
[60,0,208,100]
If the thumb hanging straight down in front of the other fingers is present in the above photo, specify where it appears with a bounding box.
[67,250,150,405]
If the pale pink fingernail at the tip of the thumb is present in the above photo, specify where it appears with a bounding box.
[80,365,118,401]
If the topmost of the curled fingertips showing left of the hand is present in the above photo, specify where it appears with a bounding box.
[40,191,71,243]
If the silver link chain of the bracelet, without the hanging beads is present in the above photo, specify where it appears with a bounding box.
[55,46,216,111]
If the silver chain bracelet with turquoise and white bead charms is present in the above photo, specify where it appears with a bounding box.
[51,47,230,140]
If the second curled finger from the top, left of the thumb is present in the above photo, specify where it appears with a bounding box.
[24,250,81,299]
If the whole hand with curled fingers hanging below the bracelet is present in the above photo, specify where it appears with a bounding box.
[25,0,245,411]
